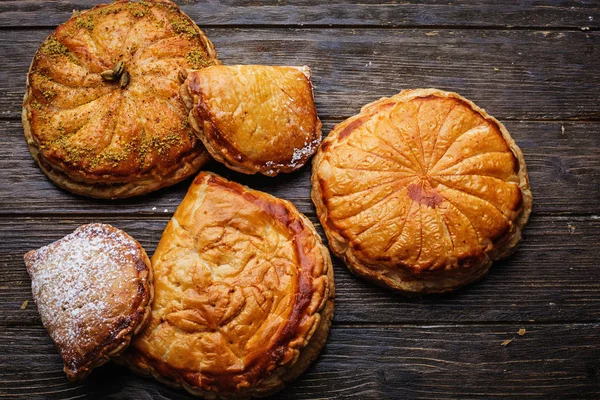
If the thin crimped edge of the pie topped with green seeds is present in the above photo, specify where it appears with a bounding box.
[21,0,221,199]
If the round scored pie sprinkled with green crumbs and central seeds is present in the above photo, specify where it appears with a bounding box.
[22,0,218,198]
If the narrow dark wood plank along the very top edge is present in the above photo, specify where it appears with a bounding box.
[0,0,600,29]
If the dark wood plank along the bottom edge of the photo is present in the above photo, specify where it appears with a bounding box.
[0,324,600,399]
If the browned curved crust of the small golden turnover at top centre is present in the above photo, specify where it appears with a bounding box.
[181,67,322,176]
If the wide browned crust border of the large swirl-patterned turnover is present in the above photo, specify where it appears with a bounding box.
[121,172,335,399]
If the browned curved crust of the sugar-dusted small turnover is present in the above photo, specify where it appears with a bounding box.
[24,224,154,382]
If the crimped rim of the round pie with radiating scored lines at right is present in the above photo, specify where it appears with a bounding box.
[311,88,533,296]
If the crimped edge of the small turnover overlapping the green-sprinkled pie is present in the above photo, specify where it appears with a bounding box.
[179,65,323,177]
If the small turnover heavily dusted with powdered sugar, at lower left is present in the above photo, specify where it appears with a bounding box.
[25,224,152,381]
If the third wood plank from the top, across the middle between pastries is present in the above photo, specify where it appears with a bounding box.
[0,119,600,215]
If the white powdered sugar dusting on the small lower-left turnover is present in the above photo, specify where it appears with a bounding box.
[25,224,145,367]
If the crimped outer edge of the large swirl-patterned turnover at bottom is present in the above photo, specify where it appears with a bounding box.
[122,172,335,400]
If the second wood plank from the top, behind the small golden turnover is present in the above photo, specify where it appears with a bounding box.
[0,28,600,120]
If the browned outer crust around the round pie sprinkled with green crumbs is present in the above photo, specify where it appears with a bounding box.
[22,0,220,199]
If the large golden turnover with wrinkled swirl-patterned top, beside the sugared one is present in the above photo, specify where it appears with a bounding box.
[121,172,334,399]
